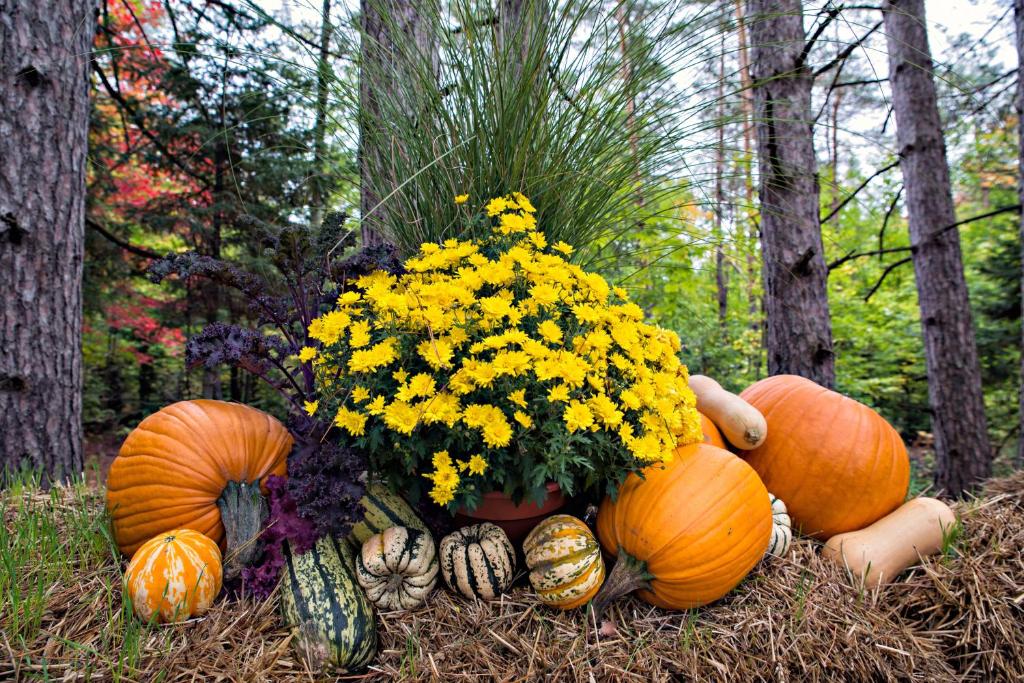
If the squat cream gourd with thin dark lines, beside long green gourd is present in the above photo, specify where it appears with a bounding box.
[355,526,437,610]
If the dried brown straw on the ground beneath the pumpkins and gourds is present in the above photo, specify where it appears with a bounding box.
[0,473,1024,682]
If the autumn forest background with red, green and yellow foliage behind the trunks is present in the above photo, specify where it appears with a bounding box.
[18,0,1024,488]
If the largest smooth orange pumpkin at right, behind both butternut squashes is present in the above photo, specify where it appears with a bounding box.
[740,375,910,540]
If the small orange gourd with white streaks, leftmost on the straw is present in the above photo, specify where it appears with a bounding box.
[125,528,221,624]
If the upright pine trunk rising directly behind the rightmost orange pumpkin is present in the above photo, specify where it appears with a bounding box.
[748,0,835,387]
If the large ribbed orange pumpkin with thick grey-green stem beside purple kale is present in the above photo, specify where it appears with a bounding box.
[106,399,292,575]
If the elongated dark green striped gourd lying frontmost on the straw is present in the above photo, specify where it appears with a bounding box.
[281,537,377,671]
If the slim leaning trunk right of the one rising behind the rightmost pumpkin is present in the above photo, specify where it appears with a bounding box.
[883,0,991,497]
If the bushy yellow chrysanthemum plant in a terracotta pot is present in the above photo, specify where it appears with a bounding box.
[300,193,700,533]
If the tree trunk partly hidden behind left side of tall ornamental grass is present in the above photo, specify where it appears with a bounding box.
[359,0,437,246]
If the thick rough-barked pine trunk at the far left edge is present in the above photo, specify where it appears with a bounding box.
[0,0,95,480]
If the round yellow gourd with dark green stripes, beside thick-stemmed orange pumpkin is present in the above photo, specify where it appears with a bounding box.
[522,515,604,609]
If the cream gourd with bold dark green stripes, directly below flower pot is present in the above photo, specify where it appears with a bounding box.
[440,522,515,600]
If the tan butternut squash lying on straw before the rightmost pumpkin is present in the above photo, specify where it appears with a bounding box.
[821,498,956,588]
